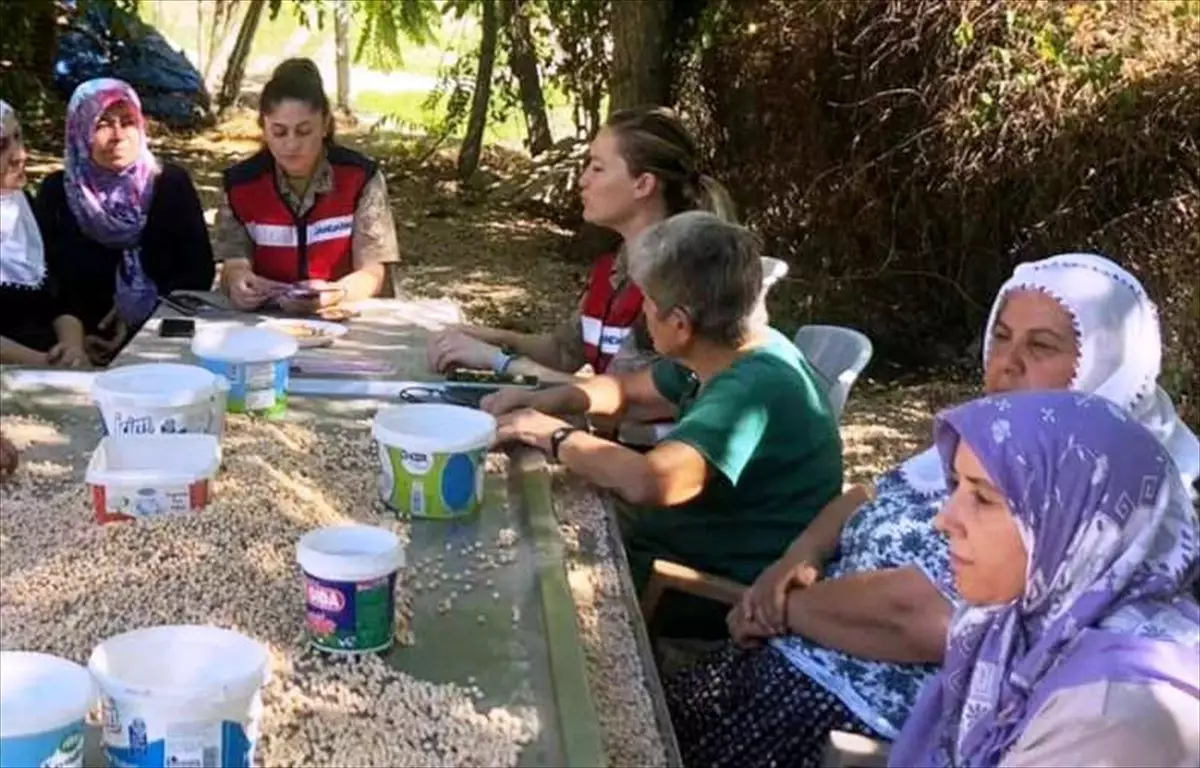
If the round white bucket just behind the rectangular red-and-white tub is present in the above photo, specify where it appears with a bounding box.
[91,362,228,437]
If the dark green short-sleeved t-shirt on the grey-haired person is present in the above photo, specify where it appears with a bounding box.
[622,329,842,589]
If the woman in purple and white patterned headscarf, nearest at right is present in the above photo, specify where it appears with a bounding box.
[889,391,1200,768]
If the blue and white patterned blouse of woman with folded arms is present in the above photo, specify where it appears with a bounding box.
[770,468,956,739]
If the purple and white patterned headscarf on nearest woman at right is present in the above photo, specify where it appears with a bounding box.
[889,391,1200,766]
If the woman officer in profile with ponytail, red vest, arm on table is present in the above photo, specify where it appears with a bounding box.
[428,107,734,382]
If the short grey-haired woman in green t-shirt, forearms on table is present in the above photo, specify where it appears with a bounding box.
[484,211,842,637]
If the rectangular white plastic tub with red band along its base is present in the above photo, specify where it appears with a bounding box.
[84,434,221,523]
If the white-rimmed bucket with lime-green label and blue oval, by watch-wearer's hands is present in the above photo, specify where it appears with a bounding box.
[372,403,496,518]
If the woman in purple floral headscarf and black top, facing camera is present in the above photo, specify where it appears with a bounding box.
[37,78,215,362]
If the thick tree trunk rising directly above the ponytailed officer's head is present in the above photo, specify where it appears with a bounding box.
[608,0,671,112]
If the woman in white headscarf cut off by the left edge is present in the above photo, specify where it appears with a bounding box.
[0,101,88,367]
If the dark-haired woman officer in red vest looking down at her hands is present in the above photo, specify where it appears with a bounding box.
[214,59,397,314]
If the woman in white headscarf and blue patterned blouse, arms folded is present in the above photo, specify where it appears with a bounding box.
[665,253,1200,766]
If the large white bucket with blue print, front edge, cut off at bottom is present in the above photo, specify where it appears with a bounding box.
[88,625,270,768]
